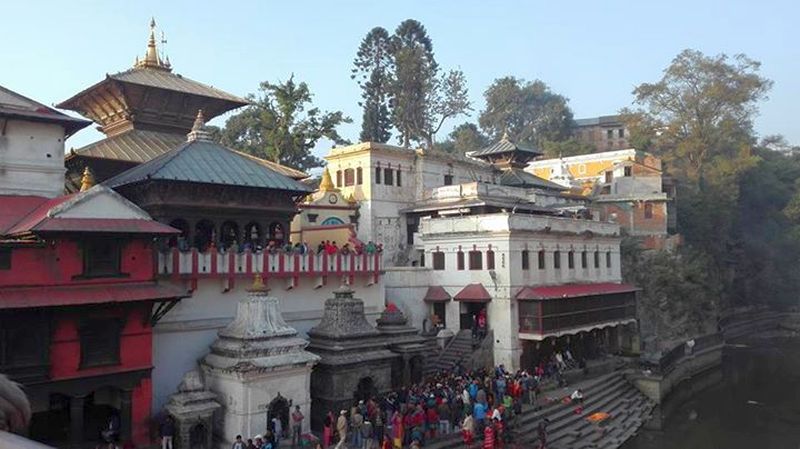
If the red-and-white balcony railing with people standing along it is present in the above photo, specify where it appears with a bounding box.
[158,248,382,288]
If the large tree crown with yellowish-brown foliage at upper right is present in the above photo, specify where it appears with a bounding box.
[633,50,772,183]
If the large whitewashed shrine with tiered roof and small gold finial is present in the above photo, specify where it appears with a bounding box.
[200,274,320,449]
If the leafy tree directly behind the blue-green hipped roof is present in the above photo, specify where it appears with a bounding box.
[220,76,352,170]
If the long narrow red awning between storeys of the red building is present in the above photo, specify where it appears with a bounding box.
[0,282,189,309]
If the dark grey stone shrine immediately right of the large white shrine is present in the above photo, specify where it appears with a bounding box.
[308,285,399,429]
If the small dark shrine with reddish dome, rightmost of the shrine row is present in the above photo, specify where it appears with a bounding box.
[376,303,438,388]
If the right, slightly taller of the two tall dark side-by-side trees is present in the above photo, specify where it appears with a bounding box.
[391,19,439,147]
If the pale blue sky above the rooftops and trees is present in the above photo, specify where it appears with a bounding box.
[0,0,800,161]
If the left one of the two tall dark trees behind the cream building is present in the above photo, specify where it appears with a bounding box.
[351,27,394,143]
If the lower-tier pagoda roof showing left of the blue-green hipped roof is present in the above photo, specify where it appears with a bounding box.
[67,129,186,163]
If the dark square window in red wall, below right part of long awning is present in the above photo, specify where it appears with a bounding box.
[79,318,122,368]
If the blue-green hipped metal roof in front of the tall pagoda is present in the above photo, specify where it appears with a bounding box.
[105,140,312,192]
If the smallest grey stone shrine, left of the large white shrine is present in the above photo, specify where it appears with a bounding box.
[166,370,220,449]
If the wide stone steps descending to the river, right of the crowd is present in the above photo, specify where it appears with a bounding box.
[426,372,654,449]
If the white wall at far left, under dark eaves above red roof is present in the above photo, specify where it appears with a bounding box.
[0,120,65,198]
